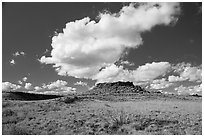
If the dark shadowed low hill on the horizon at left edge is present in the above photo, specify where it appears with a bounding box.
[2,91,62,101]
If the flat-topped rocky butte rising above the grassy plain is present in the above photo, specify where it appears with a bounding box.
[89,81,149,94]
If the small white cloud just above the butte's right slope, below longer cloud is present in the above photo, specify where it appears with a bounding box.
[150,78,173,89]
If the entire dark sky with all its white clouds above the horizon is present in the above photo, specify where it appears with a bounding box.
[2,2,202,94]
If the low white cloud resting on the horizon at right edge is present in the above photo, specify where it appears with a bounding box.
[175,84,202,95]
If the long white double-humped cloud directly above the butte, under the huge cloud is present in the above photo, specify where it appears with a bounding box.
[93,62,171,84]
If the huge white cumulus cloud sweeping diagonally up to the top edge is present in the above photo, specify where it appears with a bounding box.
[40,3,180,81]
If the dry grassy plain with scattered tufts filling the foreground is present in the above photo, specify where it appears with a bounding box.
[2,95,202,135]
